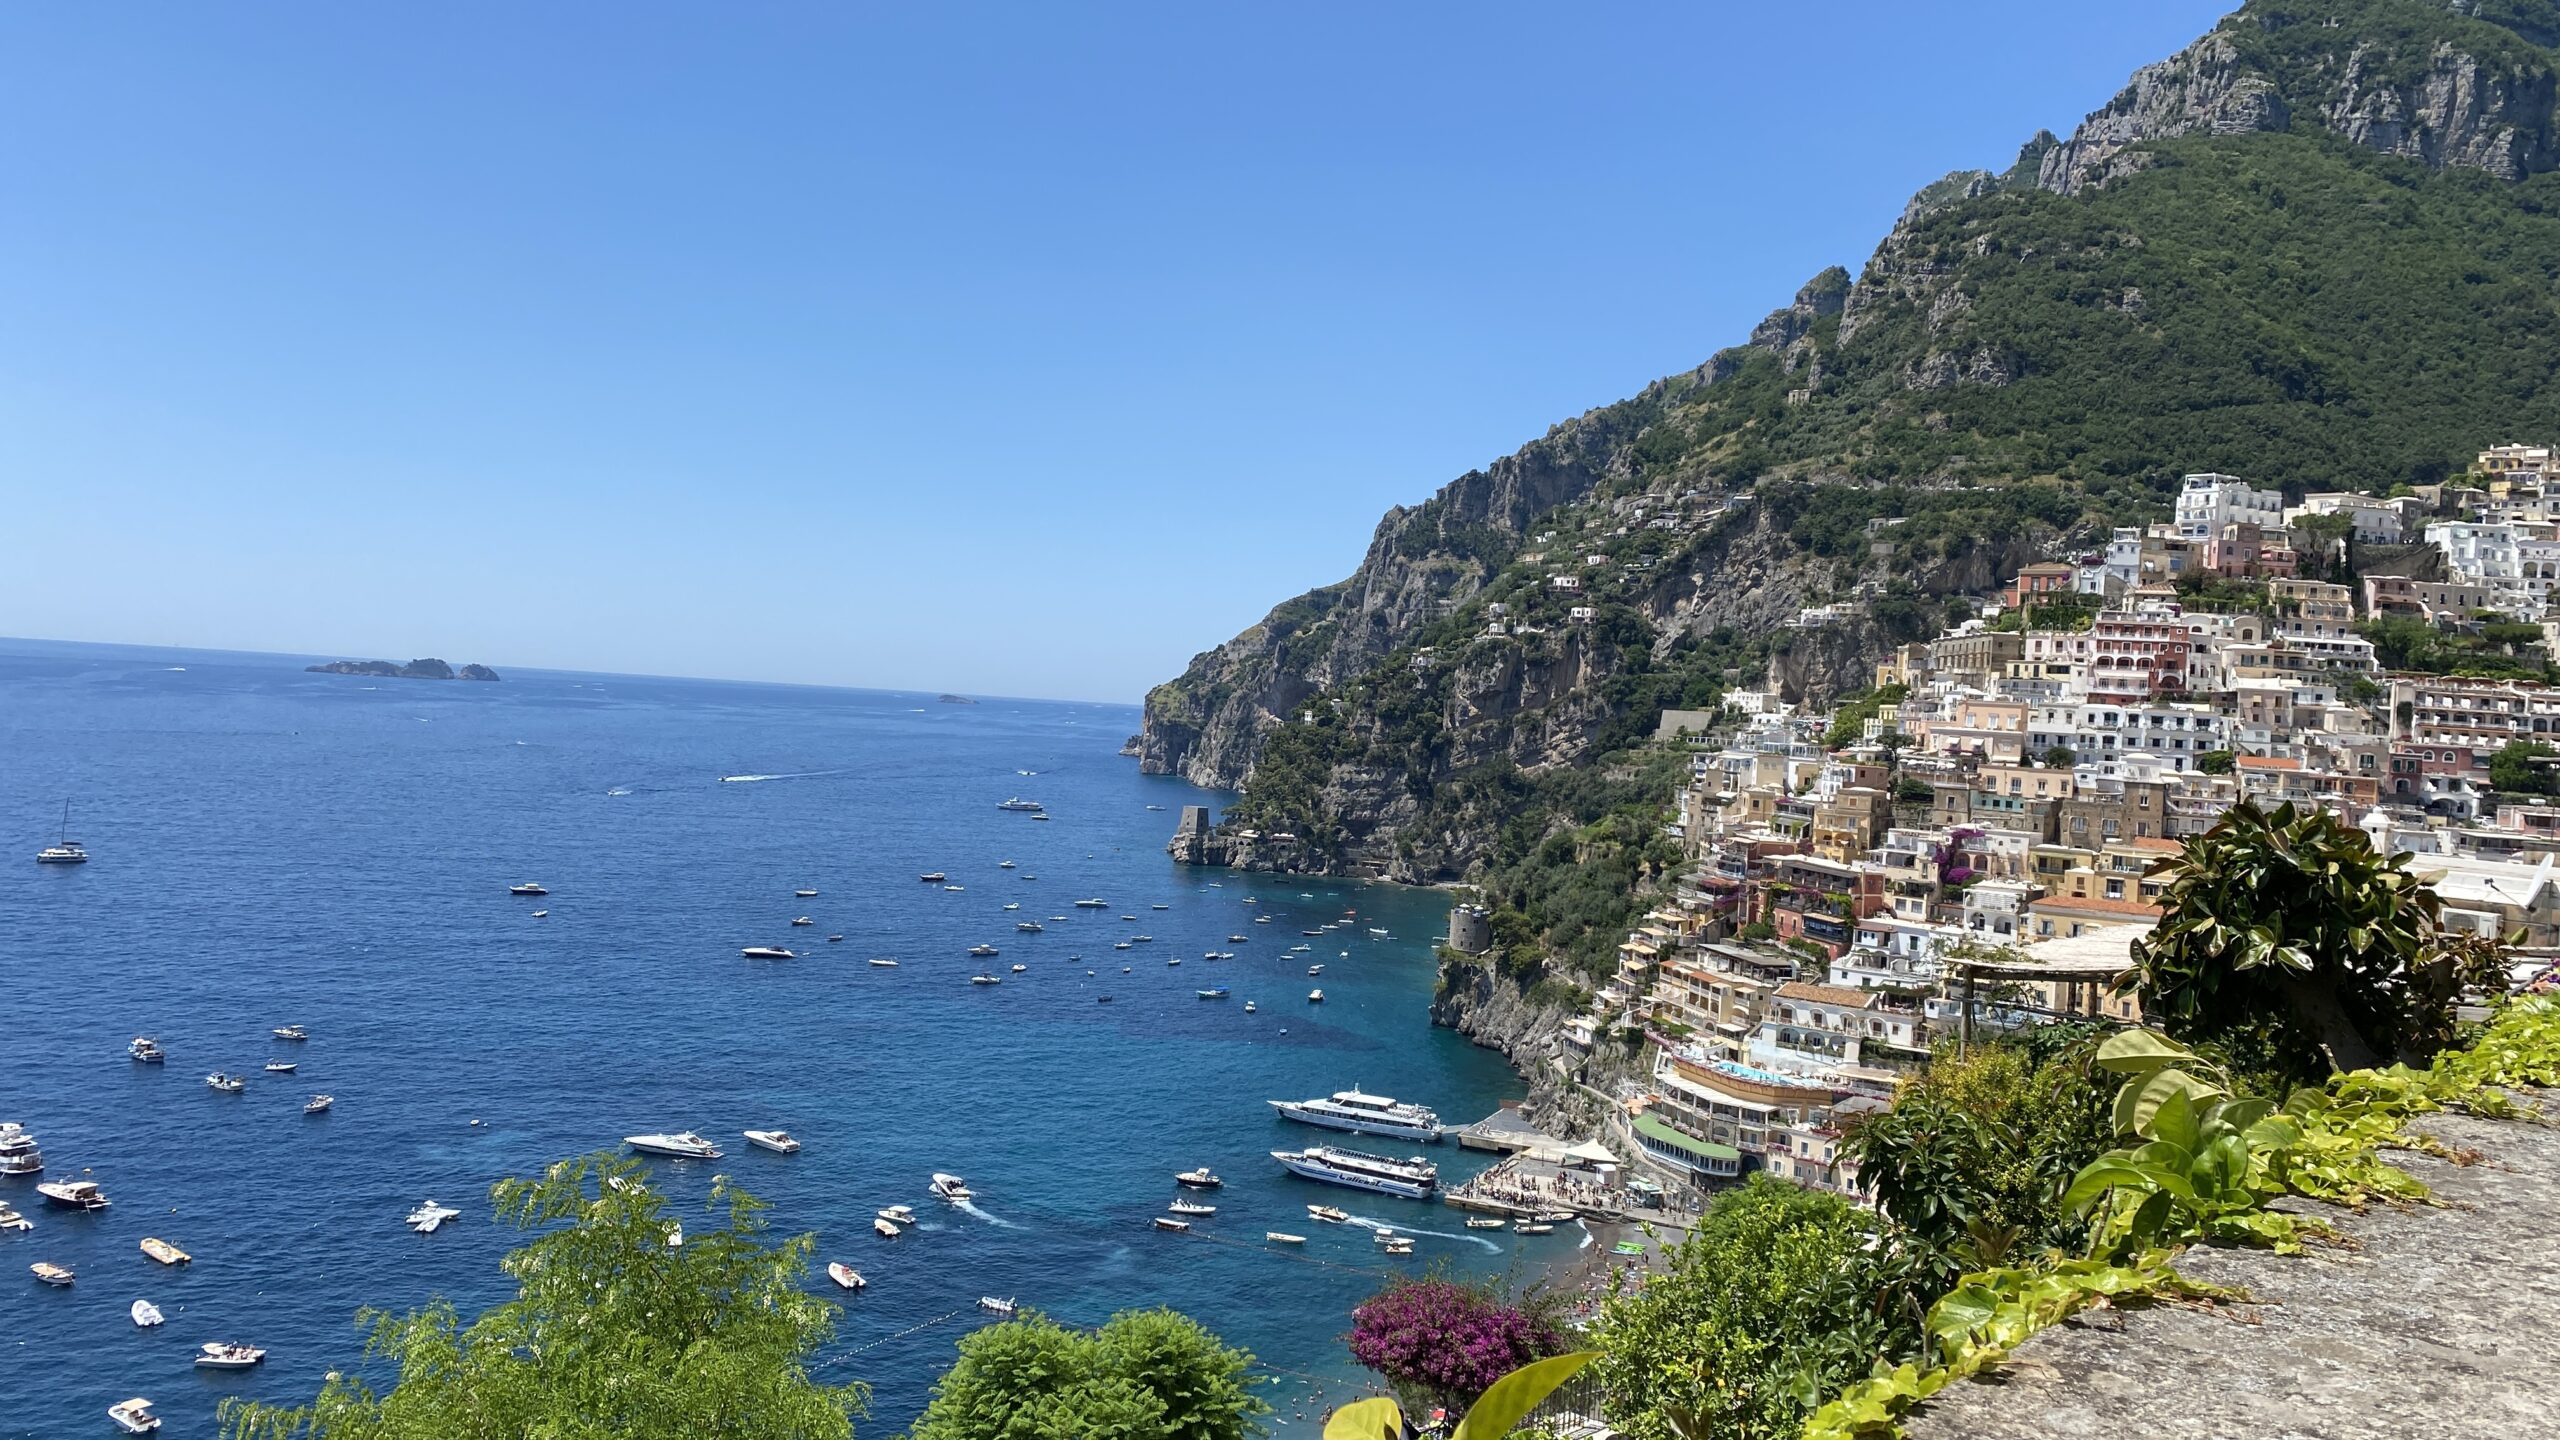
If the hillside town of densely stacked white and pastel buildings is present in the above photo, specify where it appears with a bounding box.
[1484,446,2560,1197]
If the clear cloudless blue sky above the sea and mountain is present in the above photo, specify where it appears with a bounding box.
[0,0,2222,700]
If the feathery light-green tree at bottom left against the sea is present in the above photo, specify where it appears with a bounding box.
[223,1153,868,1440]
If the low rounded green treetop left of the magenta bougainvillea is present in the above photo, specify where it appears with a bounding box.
[911,1309,1270,1440]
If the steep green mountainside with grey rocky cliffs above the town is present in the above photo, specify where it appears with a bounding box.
[1129,0,2560,948]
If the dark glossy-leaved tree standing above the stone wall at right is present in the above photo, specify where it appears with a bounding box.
[2117,799,2483,1081]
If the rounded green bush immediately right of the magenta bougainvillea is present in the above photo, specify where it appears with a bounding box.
[1592,1176,1928,1440]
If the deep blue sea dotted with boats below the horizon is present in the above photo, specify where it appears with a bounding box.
[0,641,1546,1437]
